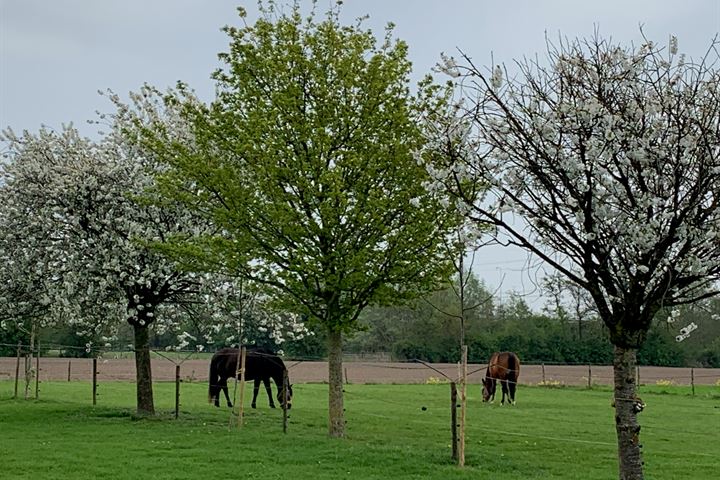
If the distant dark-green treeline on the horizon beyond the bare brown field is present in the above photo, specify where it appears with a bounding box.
[5,278,720,368]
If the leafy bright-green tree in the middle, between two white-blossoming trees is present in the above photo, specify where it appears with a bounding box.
[114,4,455,437]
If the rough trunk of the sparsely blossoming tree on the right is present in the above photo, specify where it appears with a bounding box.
[613,346,644,480]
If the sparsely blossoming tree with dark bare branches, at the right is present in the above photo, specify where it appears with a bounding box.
[426,37,720,479]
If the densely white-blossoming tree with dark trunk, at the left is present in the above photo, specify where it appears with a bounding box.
[2,127,233,414]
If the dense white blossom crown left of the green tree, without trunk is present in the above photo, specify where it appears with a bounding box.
[0,110,305,348]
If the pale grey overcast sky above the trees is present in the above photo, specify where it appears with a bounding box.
[0,0,720,308]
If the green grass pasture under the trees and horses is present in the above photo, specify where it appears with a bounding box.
[0,381,720,480]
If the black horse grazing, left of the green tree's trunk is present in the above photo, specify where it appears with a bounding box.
[208,348,292,408]
